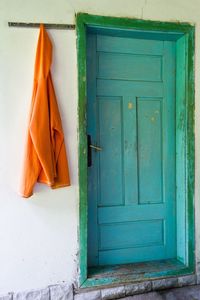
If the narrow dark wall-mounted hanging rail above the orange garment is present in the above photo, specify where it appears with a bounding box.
[8,22,75,30]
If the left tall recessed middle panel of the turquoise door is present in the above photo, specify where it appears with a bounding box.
[97,97,124,206]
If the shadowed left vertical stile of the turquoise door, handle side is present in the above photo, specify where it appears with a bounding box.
[87,34,99,265]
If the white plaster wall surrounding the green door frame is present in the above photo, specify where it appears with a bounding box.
[0,0,200,293]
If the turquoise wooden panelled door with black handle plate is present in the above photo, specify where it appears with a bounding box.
[87,33,176,266]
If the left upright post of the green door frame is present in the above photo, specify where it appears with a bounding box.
[76,14,88,283]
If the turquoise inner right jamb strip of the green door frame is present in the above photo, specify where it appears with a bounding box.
[176,36,188,264]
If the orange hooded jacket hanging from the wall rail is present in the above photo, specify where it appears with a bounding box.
[20,25,70,197]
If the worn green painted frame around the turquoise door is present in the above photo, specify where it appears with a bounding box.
[76,13,195,287]
